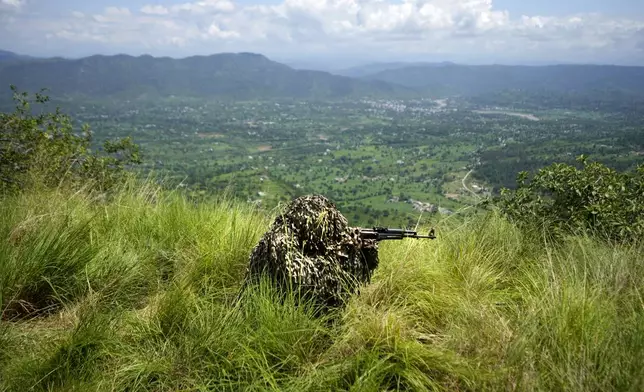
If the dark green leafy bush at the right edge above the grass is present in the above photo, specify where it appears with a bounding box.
[496,156,644,241]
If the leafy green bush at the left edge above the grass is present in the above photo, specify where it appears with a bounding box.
[0,86,141,192]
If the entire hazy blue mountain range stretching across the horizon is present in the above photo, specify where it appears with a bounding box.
[0,51,644,99]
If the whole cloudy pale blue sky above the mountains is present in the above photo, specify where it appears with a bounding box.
[0,0,644,65]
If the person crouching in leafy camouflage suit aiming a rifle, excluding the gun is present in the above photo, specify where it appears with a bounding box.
[245,196,378,307]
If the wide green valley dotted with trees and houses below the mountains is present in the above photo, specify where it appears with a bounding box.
[41,93,644,225]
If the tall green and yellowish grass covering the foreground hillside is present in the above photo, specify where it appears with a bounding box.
[0,180,644,391]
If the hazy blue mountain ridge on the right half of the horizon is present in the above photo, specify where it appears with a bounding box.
[364,64,644,95]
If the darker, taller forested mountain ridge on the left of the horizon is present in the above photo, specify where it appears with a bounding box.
[0,53,411,99]
